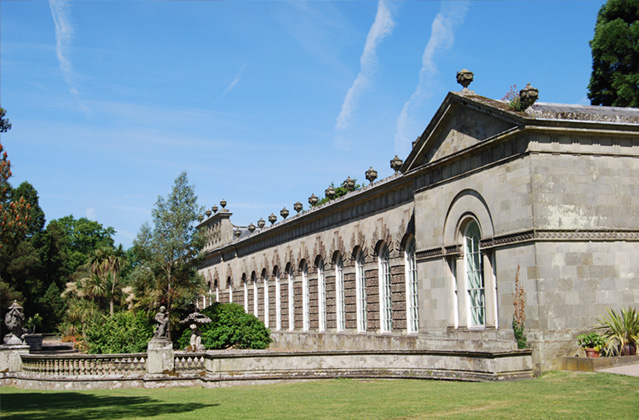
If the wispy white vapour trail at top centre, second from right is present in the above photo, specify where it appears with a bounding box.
[335,0,395,130]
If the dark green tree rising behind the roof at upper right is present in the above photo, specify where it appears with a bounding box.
[588,0,639,108]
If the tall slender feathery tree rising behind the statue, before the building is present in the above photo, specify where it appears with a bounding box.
[132,172,204,338]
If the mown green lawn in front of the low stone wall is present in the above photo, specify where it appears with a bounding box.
[0,372,639,420]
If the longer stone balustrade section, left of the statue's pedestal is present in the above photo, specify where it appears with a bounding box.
[22,353,147,377]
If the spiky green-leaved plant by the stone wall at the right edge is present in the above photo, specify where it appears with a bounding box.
[597,307,639,356]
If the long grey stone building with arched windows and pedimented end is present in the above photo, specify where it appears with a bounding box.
[199,90,639,371]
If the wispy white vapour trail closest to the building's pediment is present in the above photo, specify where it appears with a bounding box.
[395,2,469,155]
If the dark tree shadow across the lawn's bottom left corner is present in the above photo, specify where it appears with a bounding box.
[1,391,219,420]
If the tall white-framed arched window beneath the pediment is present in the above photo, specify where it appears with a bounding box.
[464,220,486,326]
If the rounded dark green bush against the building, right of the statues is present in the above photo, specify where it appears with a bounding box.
[178,303,272,349]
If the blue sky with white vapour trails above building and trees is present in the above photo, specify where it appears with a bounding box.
[0,0,604,247]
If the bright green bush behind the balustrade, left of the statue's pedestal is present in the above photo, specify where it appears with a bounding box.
[86,312,153,354]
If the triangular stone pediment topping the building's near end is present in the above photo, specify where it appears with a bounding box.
[401,92,523,172]
